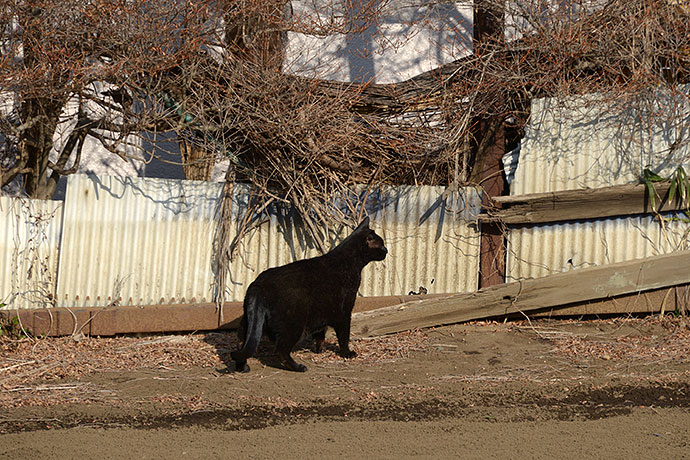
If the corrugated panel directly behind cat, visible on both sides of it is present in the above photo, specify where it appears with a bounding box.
[227,186,480,300]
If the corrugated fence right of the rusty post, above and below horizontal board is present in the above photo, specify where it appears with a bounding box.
[506,88,690,281]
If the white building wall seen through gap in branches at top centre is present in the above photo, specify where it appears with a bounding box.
[285,0,473,83]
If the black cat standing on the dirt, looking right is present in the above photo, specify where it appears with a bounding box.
[231,217,388,372]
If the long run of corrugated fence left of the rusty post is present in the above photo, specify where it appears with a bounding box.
[0,175,480,308]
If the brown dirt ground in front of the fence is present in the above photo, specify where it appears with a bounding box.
[0,317,690,460]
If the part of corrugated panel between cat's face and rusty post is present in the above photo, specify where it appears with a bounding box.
[360,186,480,296]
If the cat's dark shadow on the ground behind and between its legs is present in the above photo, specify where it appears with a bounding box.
[204,331,338,374]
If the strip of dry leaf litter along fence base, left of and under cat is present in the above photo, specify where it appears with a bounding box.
[0,331,426,392]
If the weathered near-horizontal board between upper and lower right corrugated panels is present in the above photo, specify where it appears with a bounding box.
[479,182,684,225]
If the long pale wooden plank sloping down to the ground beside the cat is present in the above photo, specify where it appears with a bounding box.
[352,251,690,337]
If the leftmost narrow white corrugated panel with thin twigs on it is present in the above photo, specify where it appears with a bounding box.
[0,197,62,309]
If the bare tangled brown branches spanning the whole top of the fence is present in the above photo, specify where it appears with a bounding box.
[0,0,690,223]
